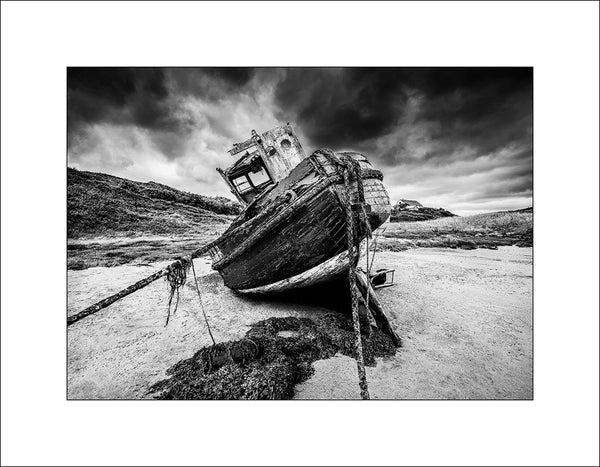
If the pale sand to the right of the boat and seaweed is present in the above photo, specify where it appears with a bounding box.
[296,247,532,399]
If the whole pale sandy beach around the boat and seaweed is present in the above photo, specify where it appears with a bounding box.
[67,247,533,399]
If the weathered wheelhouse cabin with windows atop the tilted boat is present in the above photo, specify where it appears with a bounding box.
[217,123,306,205]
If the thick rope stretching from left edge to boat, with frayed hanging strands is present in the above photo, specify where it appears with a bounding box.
[67,242,214,328]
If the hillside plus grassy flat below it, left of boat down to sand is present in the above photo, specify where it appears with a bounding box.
[67,169,242,269]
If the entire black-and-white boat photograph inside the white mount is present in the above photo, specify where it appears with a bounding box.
[67,67,534,399]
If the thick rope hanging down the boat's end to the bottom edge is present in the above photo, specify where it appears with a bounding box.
[340,157,370,400]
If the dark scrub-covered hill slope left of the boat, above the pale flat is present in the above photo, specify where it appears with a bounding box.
[67,168,241,239]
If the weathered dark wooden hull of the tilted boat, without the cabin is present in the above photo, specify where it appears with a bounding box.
[211,153,390,293]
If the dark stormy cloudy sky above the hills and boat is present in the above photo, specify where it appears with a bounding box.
[67,68,533,215]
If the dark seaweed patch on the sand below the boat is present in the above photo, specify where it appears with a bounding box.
[149,313,396,399]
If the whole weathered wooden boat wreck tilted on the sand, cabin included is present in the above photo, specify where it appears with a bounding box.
[209,124,391,293]
